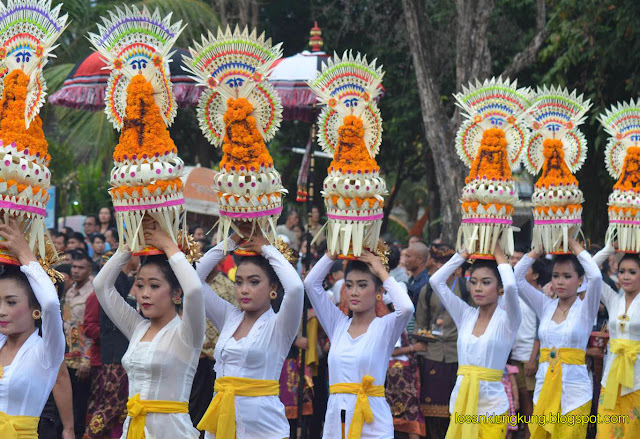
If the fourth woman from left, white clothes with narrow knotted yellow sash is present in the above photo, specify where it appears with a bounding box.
[305,252,414,439]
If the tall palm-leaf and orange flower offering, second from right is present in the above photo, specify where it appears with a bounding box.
[524,86,591,254]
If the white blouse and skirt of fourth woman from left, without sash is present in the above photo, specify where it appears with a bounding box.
[305,255,414,439]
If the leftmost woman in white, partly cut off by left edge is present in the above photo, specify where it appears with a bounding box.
[0,221,65,439]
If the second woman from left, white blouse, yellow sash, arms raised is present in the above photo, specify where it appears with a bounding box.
[93,222,205,439]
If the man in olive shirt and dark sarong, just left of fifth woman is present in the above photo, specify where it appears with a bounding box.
[416,244,469,439]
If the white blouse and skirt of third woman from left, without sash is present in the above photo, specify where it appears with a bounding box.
[196,239,304,439]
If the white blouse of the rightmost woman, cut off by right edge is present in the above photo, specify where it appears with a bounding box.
[593,246,640,396]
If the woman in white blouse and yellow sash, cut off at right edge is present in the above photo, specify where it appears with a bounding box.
[593,246,640,438]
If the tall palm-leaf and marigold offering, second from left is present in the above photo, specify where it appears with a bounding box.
[89,5,188,254]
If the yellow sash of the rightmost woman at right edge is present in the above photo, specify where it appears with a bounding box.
[602,338,640,410]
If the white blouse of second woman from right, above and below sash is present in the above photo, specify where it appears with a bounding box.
[515,250,602,415]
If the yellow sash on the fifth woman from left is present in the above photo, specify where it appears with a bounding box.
[446,366,504,439]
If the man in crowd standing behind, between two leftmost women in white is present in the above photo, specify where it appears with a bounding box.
[62,250,93,439]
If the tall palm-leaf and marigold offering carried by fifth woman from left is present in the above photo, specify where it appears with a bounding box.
[454,78,532,259]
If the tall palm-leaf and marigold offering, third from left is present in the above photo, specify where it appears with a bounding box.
[184,27,286,250]
